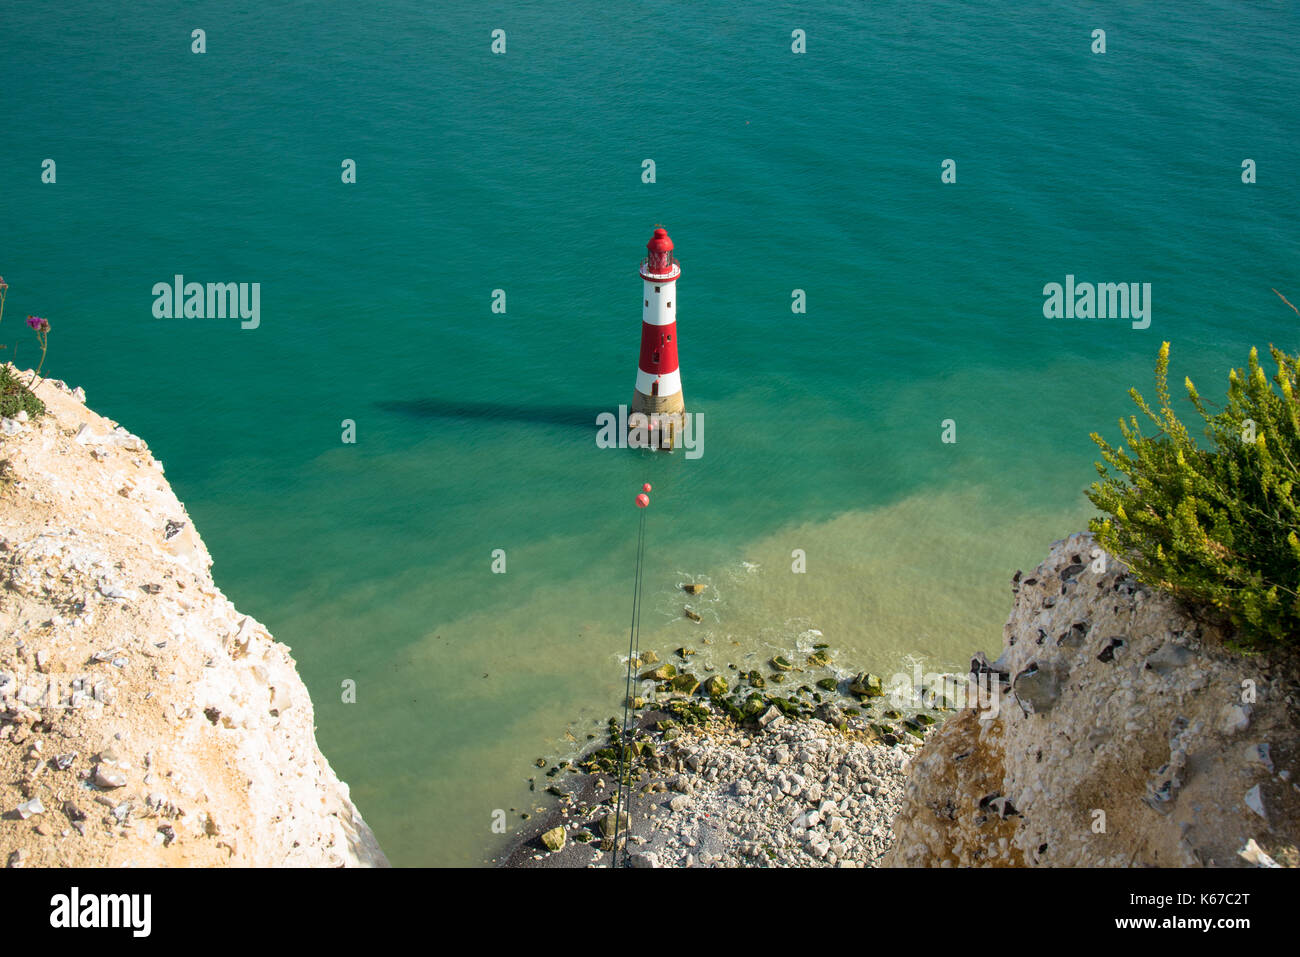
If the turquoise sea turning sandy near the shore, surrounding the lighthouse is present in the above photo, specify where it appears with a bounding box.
[0,0,1300,865]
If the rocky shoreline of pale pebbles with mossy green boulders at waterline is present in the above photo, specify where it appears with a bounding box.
[495,644,952,867]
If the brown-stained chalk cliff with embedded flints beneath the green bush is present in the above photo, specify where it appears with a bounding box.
[885,534,1300,866]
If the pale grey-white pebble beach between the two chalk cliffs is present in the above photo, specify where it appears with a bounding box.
[495,670,926,867]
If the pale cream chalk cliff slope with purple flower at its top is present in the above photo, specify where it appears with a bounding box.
[0,373,387,867]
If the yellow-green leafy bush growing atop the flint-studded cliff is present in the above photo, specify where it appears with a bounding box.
[1087,342,1300,649]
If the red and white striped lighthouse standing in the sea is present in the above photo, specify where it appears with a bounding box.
[629,226,686,450]
